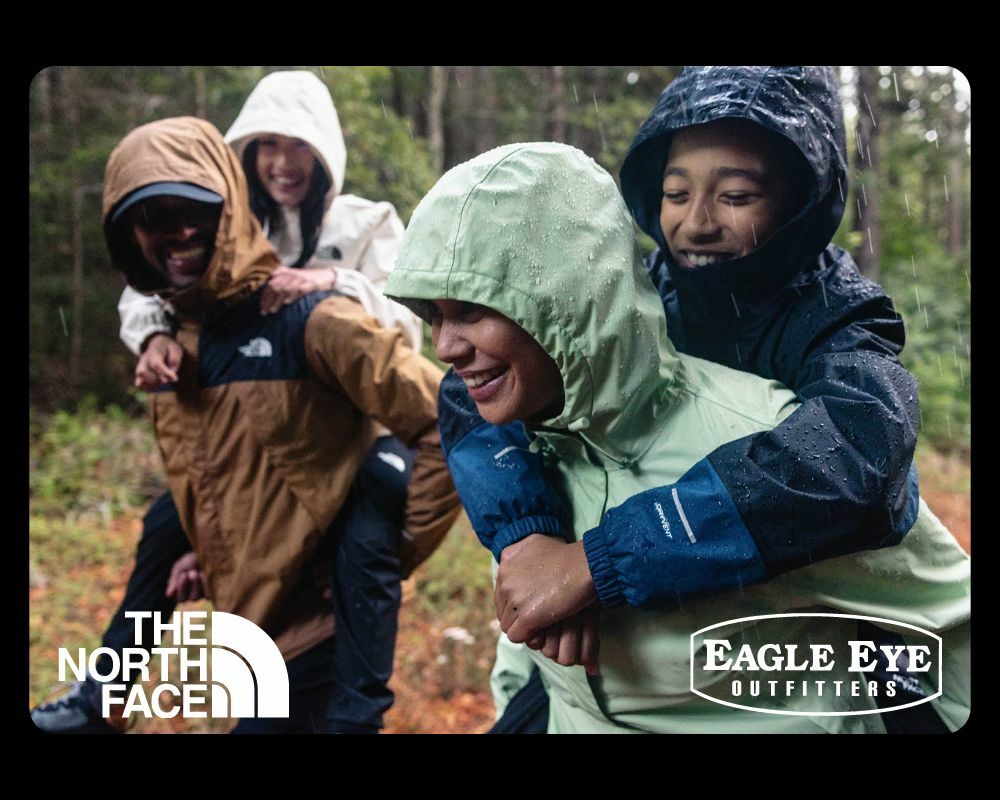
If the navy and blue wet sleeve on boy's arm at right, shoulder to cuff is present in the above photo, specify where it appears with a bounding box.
[584,274,919,607]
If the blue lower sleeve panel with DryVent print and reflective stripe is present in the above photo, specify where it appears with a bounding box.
[583,459,765,608]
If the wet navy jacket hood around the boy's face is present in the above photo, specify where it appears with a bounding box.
[621,67,847,303]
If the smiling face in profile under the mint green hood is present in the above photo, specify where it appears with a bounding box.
[431,300,566,425]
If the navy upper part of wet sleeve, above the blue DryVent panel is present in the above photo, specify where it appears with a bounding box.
[709,279,920,575]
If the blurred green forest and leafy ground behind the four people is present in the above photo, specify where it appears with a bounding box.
[28,66,972,731]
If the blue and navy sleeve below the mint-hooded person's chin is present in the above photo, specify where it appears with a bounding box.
[438,370,569,561]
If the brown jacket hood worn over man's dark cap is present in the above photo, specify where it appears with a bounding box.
[102,117,279,315]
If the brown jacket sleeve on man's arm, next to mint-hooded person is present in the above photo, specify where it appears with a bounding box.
[305,296,460,574]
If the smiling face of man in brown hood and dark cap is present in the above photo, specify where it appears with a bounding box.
[128,196,222,289]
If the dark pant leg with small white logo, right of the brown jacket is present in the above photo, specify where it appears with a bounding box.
[327,437,413,733]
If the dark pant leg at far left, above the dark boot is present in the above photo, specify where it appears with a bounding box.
[88,492,191,707]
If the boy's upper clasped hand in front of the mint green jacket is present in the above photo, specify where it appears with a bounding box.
[493,533,597,652]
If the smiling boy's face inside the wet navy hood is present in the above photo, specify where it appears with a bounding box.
[660,119,804,269]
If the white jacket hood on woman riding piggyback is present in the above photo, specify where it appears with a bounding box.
[226,71,347,213]
